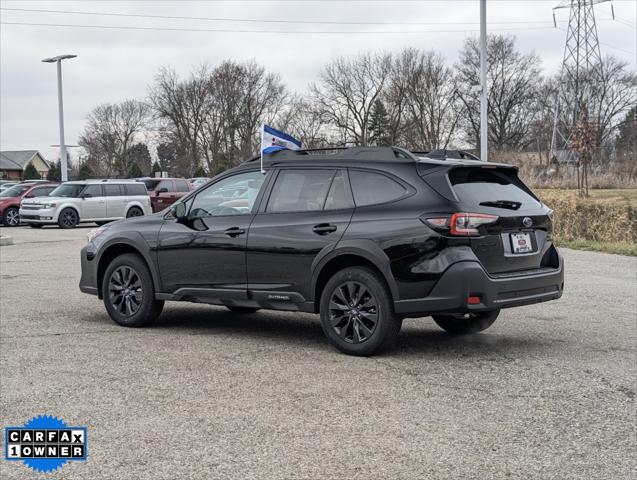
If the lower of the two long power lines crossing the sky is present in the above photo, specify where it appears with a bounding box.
[0,21,554,35]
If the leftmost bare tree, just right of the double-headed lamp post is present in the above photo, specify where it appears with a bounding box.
[79,100,149,176]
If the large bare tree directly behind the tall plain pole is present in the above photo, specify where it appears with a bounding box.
[456,35,541,150]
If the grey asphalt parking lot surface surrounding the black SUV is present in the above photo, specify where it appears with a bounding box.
[0,228,637,479]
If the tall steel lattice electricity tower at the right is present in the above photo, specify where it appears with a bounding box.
[550,0,614,163]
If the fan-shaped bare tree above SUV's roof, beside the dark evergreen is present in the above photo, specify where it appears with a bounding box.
[310,53,391,145]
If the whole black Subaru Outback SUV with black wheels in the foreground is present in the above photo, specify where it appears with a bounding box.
[80,147,564,355]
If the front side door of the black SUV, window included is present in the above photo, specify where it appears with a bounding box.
[157,170,267,298]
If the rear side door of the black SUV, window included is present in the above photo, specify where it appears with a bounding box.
[247,168,354,302]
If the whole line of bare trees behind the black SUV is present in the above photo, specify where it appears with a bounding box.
[79,35,637,177]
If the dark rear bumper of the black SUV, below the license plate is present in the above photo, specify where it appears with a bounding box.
[394,256,564,315]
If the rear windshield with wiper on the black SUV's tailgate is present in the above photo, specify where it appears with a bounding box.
[449,167,540,210]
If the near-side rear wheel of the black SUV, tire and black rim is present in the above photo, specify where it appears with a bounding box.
[320,267,402,356]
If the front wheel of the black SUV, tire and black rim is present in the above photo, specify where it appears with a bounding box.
[102,253,164,327]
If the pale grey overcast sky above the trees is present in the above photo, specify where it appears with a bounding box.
[0,0,637,159]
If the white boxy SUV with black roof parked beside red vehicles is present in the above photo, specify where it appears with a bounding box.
[19,180,152,228]
